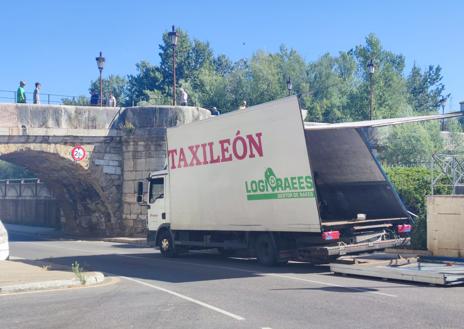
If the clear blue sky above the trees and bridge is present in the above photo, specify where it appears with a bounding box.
[0,0,464,111]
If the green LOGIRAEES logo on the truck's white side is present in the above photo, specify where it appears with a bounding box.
[245,168,314,201]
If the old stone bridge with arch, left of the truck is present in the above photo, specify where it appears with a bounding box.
[0,104,210,236]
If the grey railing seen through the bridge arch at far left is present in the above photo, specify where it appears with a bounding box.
[0,178,54,199]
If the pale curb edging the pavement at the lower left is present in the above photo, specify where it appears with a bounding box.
[0,272,105,294]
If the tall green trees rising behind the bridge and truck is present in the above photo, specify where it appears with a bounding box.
[85,29,452,165]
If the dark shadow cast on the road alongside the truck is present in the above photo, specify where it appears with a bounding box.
[22,253,328,283]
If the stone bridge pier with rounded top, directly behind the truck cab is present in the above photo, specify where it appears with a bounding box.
[116,106,211,235]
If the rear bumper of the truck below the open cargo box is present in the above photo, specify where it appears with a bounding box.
[298,238,410,261]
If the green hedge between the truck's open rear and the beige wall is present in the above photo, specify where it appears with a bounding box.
[385,167,449,249]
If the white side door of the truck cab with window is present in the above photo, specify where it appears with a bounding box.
[148,177,166,231]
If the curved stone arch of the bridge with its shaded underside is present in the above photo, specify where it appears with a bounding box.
[0,144,120,235]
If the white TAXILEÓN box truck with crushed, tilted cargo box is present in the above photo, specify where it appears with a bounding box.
[137,97,442,265]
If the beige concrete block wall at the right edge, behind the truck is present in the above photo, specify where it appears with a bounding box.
[427,195,464,257]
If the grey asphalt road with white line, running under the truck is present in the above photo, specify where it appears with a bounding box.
[0,228,464,329]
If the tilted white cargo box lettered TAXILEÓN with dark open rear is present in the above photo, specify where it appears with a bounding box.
[167,97,408,232]
